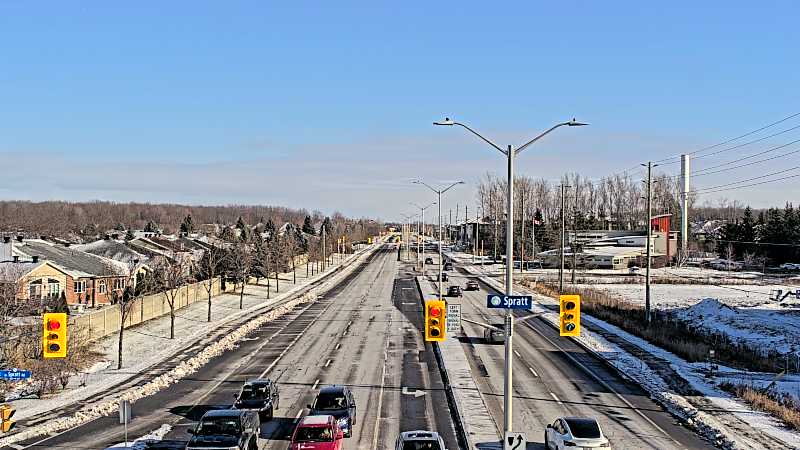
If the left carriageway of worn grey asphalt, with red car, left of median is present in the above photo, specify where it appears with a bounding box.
[4,246,458,450]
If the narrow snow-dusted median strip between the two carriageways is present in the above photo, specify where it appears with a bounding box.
[416,276,502,450]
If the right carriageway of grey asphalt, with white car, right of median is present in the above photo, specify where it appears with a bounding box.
[445,264,714,450]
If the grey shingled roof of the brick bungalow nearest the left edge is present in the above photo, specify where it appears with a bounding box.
[14,239,128,278]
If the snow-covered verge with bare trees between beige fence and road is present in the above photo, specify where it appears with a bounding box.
[7,249,367,421]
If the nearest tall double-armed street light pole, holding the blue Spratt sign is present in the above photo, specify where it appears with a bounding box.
[433,118,587,433]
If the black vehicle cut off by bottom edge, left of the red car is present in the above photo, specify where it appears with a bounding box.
[186,409,261,450]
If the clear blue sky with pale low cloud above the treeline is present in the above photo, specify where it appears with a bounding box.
[0,1,800,218]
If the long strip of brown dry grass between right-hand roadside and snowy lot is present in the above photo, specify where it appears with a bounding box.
[524,282,784,372]
